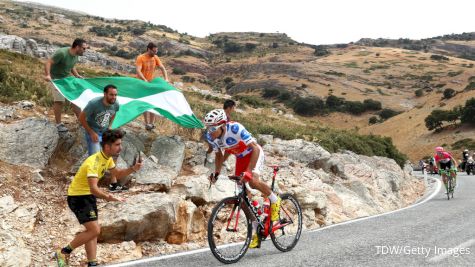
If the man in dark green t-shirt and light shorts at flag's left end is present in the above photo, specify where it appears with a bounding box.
[45,38,87,132]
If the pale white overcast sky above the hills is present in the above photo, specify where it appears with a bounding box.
[17,0,475,44]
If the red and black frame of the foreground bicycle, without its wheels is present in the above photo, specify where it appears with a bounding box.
[226,166,293,237]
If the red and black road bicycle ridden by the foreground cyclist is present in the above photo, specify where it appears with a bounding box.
[208,166,302,264]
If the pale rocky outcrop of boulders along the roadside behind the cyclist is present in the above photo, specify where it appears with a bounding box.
[0,102,424,266]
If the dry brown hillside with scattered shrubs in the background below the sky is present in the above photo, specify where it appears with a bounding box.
[0,1,475,161]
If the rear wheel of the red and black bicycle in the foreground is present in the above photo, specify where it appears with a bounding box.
[270,194,302,252]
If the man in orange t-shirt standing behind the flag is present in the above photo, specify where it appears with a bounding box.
[135,43,168,131]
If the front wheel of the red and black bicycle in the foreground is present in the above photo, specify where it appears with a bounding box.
[208,197,252,264]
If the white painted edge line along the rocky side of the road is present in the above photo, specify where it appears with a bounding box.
[107,177,442,267]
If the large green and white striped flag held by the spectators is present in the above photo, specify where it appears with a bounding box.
[53,77,204,128]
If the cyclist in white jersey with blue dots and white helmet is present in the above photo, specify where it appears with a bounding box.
[204,109,281,248]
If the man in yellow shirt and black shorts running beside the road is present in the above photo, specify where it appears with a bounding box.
[55,129,142,267]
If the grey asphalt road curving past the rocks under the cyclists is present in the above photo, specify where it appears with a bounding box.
[108,173,475,267]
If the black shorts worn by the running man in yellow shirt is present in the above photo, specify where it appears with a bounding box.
[68,195,97,224]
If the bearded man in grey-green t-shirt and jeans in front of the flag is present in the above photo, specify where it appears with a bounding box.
[79,84,124,192]
